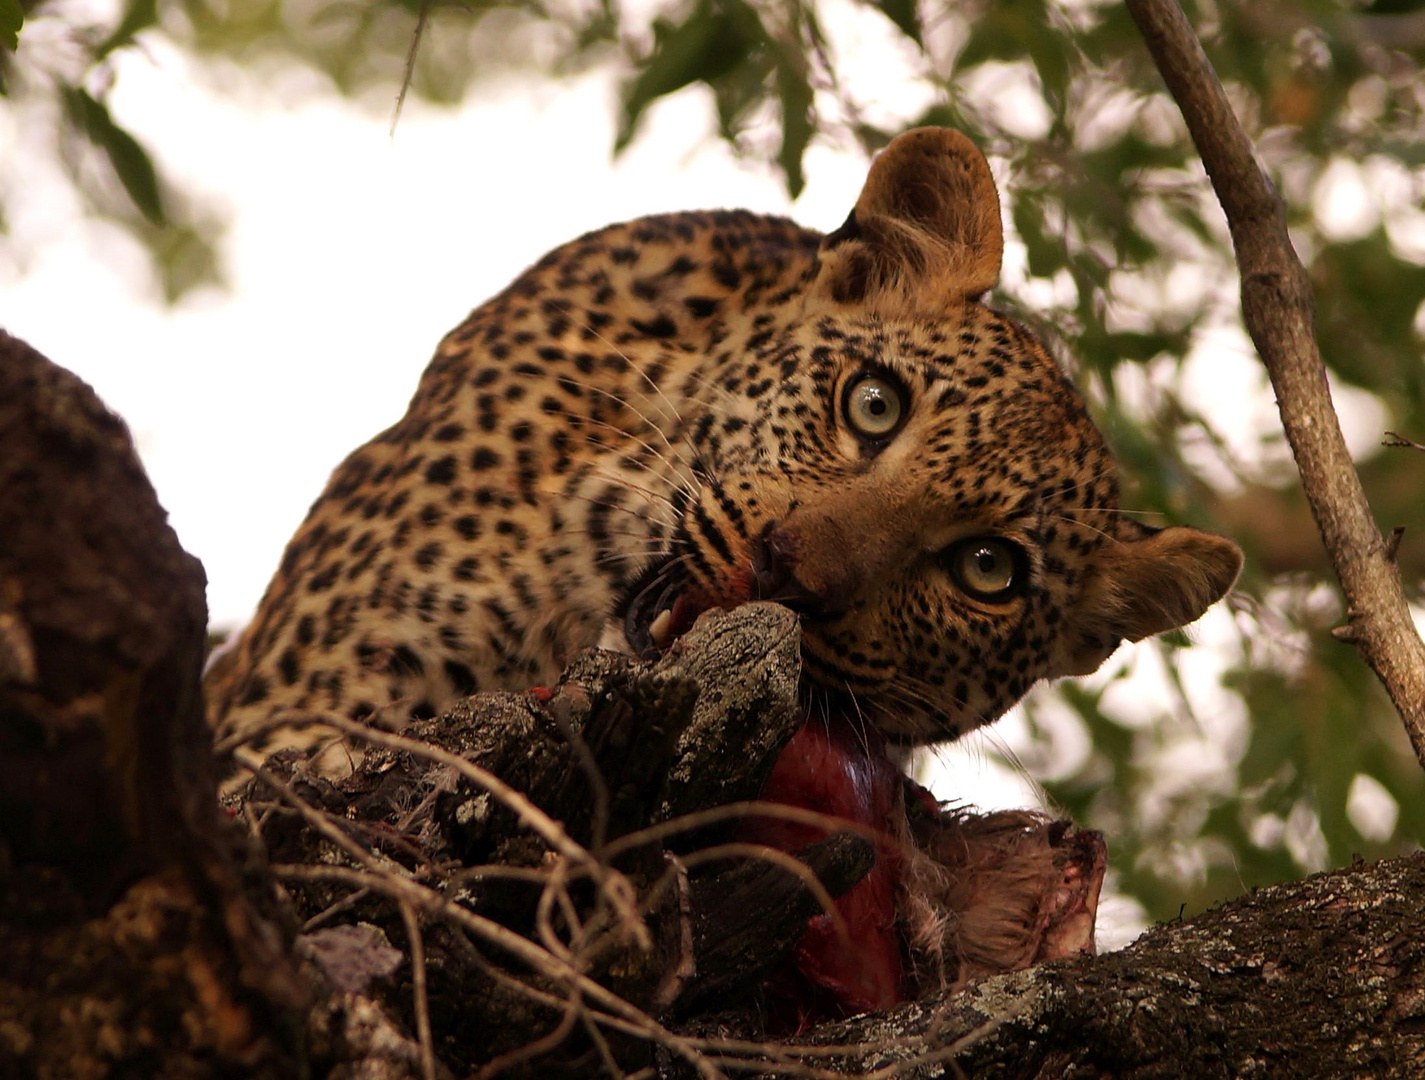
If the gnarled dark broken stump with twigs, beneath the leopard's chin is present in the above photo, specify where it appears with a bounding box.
[235,604,875,1076]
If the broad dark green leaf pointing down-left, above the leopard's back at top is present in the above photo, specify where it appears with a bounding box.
[614,0,762,152]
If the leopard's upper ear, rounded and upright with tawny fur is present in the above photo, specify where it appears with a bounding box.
[817,128,1005,311]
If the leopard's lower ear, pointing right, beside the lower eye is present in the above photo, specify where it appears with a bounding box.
[1059,526,1243,675]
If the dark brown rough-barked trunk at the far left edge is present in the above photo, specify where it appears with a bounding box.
[0,332,413,1080]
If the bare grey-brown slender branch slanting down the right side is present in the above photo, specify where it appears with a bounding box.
[1124,0,1425,765]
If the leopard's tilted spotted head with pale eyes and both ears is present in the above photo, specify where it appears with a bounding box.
[626,128,1241,742]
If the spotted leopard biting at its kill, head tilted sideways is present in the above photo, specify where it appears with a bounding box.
[205,128,1241,775]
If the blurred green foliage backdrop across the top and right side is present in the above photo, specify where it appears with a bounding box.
[8,0,1425,918]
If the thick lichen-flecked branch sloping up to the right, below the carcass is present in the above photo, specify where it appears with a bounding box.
[763,853,1425,1080]
